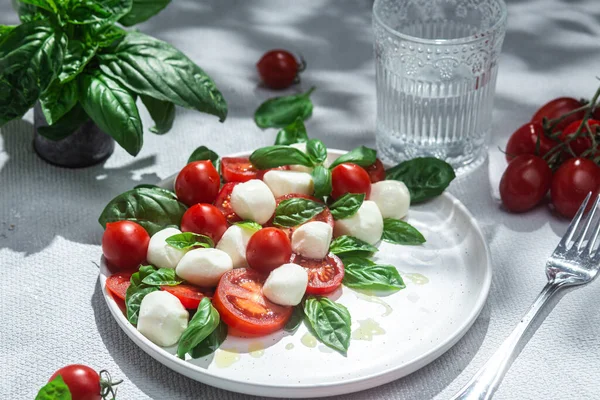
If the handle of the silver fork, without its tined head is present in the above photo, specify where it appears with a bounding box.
[451,280,564,400]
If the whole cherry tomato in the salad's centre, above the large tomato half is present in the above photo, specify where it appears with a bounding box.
[246,228,292,273]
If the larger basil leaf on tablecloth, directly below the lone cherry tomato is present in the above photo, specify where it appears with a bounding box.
[254,88,315,128]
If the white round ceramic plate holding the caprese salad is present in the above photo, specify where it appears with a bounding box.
[100,150,492,398]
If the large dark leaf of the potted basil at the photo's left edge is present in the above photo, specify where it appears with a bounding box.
[0,21,67,126]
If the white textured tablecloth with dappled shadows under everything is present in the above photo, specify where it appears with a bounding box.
[0,0,600,400]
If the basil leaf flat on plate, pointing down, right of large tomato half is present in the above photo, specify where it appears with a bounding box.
[304,296,351,355]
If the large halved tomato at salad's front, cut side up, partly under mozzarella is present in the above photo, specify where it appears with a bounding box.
[213,268,293,335]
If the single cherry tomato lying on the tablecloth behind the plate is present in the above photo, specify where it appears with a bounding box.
[256,50,300,89]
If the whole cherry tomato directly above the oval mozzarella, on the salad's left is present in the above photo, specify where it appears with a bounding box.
[181,204,227,244]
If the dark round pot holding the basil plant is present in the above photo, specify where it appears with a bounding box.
[33,102,115,168]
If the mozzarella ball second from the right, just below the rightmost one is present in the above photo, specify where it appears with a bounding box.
[333,200,383,244]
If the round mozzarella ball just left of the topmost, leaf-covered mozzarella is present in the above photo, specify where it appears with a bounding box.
[231,179,276,224]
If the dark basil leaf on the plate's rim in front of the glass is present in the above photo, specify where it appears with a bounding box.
[385,157,456,204]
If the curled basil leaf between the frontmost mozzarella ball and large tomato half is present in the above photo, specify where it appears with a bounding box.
[177,297,220,359]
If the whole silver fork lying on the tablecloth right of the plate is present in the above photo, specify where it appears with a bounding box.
[452,193,600,400]
